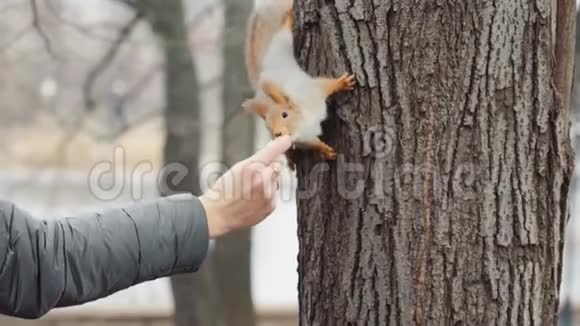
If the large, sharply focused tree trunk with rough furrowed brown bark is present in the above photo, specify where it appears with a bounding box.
[295,0,572,325]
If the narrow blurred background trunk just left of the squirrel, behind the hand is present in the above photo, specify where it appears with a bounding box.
[212,0,256,326]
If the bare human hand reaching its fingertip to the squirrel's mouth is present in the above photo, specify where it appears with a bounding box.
[200,136,292,238]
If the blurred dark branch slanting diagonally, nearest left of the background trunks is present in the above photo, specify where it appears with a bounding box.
[83,12,141,112]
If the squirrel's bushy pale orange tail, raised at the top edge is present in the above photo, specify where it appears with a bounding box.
[245,0,293,89]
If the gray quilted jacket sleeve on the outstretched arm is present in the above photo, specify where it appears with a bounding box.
[0,195,209,318]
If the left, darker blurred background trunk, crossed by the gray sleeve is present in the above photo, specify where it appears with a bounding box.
[138,0,220,326]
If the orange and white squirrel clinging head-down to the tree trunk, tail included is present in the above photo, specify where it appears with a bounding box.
[242,0,356,170]
